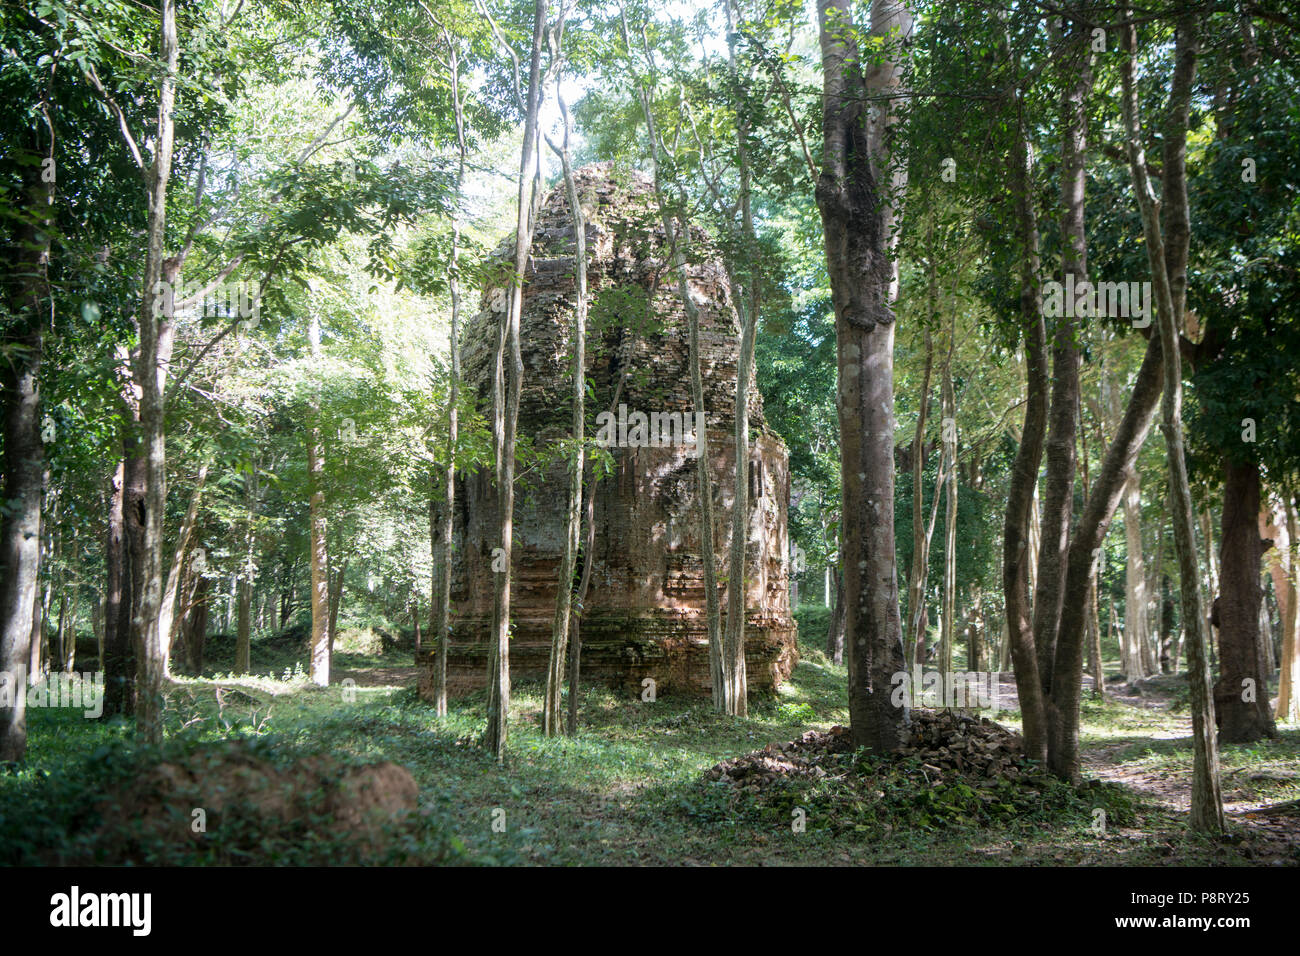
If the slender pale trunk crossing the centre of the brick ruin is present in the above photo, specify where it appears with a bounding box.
[542,92,586,736]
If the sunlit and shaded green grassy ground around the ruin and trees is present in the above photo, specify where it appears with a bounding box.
[0,621,1300,865]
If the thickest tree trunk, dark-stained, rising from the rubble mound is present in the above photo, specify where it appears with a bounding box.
[816,0,911,752]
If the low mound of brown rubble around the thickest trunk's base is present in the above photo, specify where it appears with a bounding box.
[705,710,1024,790]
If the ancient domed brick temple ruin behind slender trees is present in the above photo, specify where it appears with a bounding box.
[419,164,797,696]
